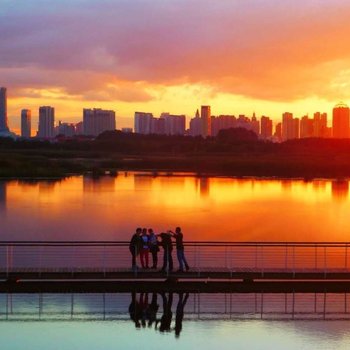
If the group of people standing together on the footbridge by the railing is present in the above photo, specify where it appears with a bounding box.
[129,227,190,272]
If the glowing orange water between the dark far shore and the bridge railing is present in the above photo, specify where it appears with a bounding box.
[0,173,350,241]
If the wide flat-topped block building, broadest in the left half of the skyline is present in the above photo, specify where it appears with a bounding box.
[83,108,116,136]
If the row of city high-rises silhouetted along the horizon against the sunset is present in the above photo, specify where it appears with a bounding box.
[0,87,350,142]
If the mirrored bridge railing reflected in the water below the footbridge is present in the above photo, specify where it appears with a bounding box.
[0,293,350,321]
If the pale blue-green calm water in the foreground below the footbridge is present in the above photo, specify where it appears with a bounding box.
[0,294,350,350]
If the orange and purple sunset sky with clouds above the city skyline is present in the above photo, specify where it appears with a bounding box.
[0,0,350,129]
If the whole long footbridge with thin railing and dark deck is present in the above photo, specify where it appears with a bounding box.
[0,242,350,291]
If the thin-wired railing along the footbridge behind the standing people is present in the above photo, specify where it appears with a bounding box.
[0,241,350,273]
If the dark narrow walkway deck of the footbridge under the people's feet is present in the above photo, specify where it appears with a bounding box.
[0,267,350,280]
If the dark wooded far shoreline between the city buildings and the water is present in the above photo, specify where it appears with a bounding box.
[0,130,350,180]
